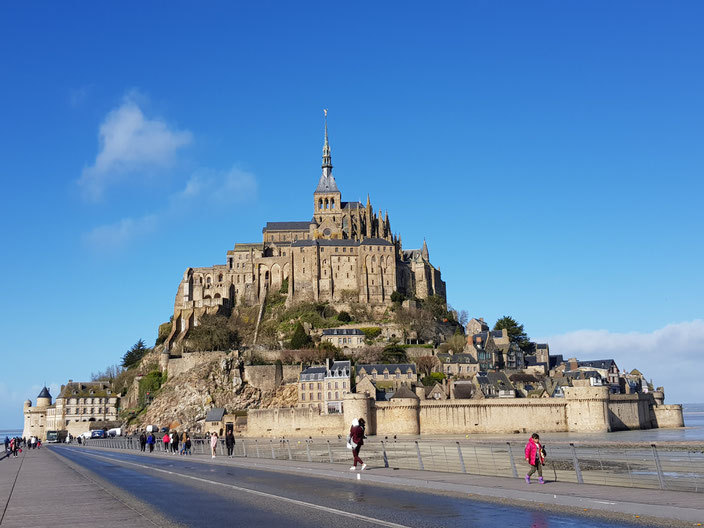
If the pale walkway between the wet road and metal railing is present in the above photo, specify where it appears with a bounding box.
[74,447,704,526]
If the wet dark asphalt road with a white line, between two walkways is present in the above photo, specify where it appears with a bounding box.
[52,447,648,528]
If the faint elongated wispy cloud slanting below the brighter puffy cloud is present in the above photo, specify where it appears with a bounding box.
[84,168,257,252]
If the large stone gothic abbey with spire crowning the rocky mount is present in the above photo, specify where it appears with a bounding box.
[166,122,445,348]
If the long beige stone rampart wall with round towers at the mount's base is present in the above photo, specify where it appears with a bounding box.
[247,387,683,437]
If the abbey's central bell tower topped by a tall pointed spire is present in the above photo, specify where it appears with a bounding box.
[313,109,343,239]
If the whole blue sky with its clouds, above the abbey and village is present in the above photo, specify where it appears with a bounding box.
[0,2,704,426]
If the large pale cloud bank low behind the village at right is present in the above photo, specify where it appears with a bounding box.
[537,319,704,403]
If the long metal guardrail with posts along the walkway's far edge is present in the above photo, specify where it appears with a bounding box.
[80,437,704,493]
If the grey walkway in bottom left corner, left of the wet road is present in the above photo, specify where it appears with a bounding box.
[0,447,167,528]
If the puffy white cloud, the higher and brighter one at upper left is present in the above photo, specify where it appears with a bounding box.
[78,92,193,200]
